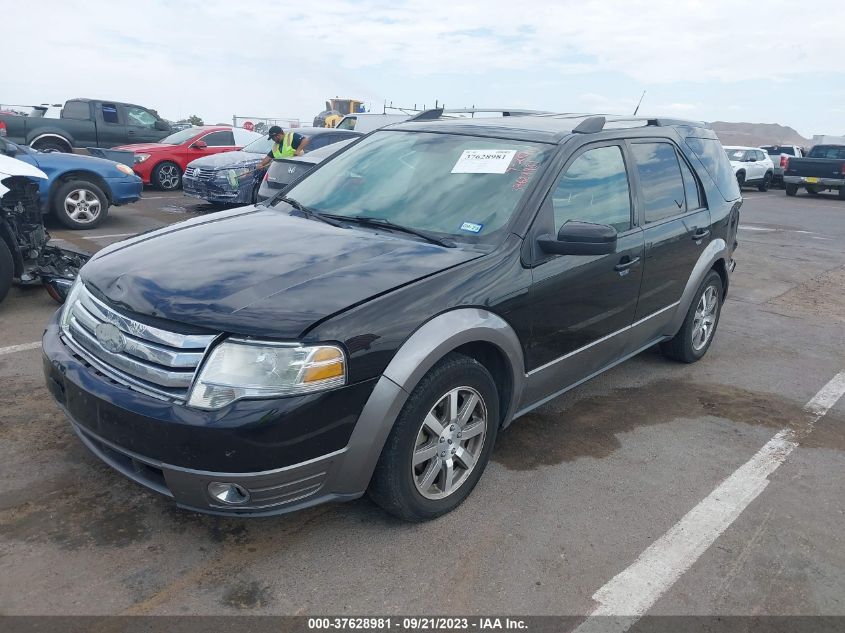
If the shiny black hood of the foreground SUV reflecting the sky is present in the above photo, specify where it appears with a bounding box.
[82,207,481,339]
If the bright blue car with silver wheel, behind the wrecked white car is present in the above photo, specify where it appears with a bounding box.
[0,138,143,229]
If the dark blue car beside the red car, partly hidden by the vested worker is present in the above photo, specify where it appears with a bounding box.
[182,127,363,204]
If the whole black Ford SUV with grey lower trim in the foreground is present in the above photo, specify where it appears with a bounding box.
[43,115,741,520]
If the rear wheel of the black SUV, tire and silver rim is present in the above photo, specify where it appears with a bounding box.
[660,270,723,363]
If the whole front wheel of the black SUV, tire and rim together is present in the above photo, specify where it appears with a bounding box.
[368,353,499,521]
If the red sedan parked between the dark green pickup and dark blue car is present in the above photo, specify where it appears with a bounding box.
[112,125,262,191]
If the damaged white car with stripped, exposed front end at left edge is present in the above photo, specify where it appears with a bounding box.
[0,155,90,303]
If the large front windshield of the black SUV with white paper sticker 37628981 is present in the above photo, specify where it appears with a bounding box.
[278,131,554,243]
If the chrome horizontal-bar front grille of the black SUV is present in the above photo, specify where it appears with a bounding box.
[63,287,215,402]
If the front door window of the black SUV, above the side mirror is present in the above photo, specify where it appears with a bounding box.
[552,145,631,232]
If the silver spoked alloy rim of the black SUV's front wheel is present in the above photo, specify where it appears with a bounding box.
[411,387,487,499]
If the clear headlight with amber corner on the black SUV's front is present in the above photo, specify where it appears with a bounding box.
[188,339,346,409]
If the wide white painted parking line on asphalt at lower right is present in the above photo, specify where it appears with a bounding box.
[575,371,845,633]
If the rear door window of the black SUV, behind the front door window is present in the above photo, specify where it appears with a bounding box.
[631,143,684,224]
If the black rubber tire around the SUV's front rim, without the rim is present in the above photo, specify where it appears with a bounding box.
[368,353,499,521]
